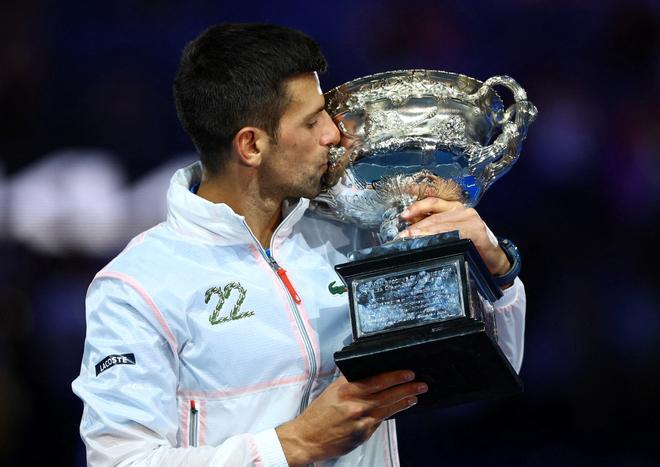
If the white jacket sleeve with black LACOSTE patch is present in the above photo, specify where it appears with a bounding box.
[72,274,287,466]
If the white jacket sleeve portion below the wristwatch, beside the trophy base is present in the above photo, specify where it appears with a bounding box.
[493,278,526,373]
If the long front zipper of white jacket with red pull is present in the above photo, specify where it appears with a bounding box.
[243,209,318,413]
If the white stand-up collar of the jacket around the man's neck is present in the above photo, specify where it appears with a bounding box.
[167,161,309,245]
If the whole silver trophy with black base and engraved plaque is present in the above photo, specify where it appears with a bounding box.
[312,70,537,414]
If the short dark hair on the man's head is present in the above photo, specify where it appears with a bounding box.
[174,24,327,173]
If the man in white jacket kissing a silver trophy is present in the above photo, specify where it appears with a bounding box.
[73,24,524,466]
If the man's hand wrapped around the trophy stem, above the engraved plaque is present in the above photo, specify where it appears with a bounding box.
[399,197,511,276]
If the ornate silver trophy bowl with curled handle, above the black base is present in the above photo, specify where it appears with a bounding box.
[312,70,536,241]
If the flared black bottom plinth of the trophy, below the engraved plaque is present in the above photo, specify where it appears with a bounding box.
[335,319,522,418]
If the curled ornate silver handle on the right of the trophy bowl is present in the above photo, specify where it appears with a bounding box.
[475,76,537,190]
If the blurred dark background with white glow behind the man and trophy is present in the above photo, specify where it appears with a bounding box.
[0,0,660,466]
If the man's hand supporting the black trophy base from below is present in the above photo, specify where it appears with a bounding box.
[276,370,428,465]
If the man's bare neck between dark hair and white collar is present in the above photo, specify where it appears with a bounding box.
[197,168,282,248]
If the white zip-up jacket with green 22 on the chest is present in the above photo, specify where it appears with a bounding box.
[73,163,525,466]
